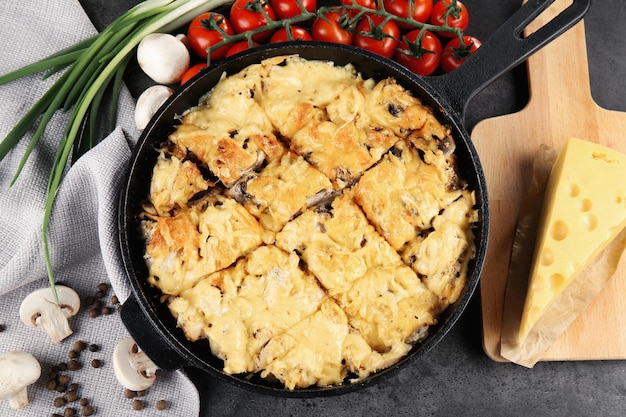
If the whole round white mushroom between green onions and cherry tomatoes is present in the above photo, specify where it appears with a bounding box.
[137,33,191,84]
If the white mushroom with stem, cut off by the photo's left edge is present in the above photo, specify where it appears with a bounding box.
[0,351,41,409]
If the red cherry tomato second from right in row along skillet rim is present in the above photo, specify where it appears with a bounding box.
[395,29,442,75]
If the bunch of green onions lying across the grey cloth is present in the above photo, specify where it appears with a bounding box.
[0,0,232,303]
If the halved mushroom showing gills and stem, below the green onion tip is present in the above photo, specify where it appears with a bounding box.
[20,285,80,344]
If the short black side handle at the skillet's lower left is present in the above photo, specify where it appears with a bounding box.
[120,295,189,371]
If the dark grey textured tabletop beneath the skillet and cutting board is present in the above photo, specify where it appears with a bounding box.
[81,0,626,417]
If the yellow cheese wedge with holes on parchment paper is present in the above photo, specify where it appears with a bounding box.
[519,138,626,343]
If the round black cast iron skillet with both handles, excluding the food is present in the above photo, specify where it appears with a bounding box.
[119,0,590,397]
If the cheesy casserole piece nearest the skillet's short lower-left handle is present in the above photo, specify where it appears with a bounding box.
[169,245,324,374]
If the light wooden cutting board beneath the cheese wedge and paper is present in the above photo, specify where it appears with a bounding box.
[471,0,626,362]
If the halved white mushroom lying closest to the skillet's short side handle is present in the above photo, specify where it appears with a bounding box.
[113,337,158,391]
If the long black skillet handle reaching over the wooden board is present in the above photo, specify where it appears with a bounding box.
[428,0,591,123]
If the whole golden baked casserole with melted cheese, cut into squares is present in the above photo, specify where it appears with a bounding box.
[141,56,478,390]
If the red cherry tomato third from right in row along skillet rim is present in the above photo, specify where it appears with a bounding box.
[354,15,400,58]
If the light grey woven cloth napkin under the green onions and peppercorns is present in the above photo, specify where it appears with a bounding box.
[0,0,199,417]
